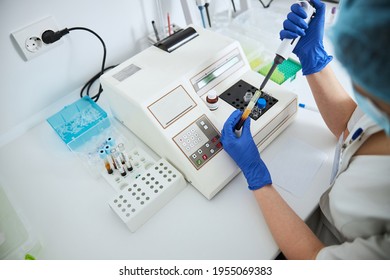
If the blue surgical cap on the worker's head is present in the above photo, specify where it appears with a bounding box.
[329,0,390,103]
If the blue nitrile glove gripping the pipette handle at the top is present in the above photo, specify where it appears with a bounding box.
[280,0,332,75]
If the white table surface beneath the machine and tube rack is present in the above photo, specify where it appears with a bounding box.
[0,83,335,259]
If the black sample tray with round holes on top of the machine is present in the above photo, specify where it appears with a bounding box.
[219,80,278,120]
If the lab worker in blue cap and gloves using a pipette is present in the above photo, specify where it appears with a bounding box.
[221,0,390,259]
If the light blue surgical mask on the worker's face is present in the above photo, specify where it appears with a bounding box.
[354,89,390,136]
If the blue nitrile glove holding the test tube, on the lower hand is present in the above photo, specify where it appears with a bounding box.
[221,110,272,190]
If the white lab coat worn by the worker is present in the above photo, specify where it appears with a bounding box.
[317,108,390,260]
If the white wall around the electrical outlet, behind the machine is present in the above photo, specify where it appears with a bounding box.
[0,0,189,139]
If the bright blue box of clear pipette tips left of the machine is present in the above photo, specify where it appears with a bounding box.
[47,96,110,150]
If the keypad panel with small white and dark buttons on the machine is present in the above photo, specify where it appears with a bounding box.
[173,115,222,169]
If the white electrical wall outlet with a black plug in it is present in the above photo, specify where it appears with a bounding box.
[11,16,62,60]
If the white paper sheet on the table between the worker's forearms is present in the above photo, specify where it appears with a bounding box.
[267,139,328,196]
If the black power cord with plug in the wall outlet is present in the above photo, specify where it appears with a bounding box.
[42,26,112,102]
